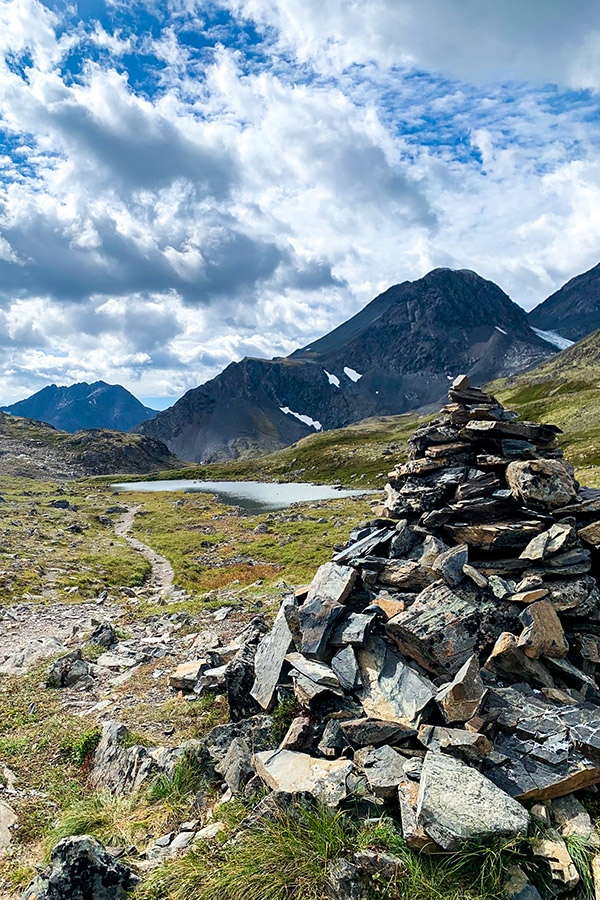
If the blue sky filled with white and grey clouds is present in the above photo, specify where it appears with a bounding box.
[0,0,600,406]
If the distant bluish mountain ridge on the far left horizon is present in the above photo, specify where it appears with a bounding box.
[0,381,156,432]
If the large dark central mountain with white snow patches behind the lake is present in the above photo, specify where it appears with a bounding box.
[134,269,556,462]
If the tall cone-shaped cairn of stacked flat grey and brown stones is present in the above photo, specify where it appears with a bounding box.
[241,377,600,889]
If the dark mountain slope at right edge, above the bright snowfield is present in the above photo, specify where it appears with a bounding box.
[529,264,600,341]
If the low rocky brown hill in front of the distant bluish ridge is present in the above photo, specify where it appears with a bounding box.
[0,412,181,478]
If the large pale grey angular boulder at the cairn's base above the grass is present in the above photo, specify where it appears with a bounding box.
[417,752,529,850]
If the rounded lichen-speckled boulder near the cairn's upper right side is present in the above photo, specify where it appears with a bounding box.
[506,459,576,510]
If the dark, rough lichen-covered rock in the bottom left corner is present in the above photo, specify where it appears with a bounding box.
[22,835,138,900]
